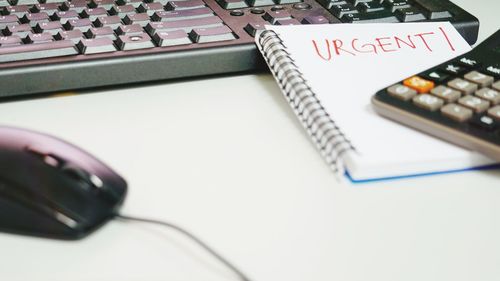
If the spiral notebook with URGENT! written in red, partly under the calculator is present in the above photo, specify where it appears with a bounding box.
[256,22,497,182]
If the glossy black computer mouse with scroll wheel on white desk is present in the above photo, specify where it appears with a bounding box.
[0,126,127,240]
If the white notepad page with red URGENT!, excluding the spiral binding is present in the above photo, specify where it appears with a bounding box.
[266,22,494,180]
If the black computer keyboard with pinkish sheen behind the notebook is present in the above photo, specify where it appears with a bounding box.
[0,0,479,97]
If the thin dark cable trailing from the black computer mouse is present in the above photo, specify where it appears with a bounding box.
[115,214,250,281]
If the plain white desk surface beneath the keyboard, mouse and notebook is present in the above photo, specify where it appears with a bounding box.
[0,0,500,281]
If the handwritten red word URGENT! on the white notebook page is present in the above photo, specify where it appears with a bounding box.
[312,27,455,61]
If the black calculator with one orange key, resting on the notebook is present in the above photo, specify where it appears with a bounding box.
[372,30,500,161]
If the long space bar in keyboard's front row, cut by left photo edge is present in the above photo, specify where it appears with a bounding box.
[0,38,78,63]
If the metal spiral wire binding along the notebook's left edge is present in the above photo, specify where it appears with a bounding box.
[258,30,356,174]
